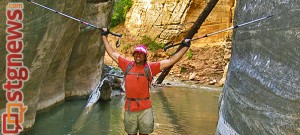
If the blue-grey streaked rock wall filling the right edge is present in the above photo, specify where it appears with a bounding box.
[217,0,300,135]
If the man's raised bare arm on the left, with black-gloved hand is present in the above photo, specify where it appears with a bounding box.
[101,28,120,63]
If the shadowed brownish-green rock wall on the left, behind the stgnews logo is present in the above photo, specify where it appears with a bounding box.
[0,0,113,128]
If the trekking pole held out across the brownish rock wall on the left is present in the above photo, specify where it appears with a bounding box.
[27,0,122,37]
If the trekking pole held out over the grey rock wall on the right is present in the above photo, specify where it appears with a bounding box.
[164,14,274,51]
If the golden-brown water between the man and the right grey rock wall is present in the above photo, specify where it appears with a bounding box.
[152,88,220,135]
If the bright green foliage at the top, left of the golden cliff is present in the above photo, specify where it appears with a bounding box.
[110,0,132,28]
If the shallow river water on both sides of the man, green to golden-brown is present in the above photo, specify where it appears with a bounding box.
[26,87,221,135]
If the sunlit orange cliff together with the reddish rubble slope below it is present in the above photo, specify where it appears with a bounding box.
[106,0,235,85]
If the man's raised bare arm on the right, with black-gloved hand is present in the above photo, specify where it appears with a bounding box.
[160,39,190,70]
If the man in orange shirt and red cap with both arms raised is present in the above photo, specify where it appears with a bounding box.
[101,28,190,135]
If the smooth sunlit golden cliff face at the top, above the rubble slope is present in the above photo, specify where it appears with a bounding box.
[125,0,235,46]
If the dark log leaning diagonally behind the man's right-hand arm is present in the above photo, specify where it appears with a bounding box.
[155,0,219,84]
